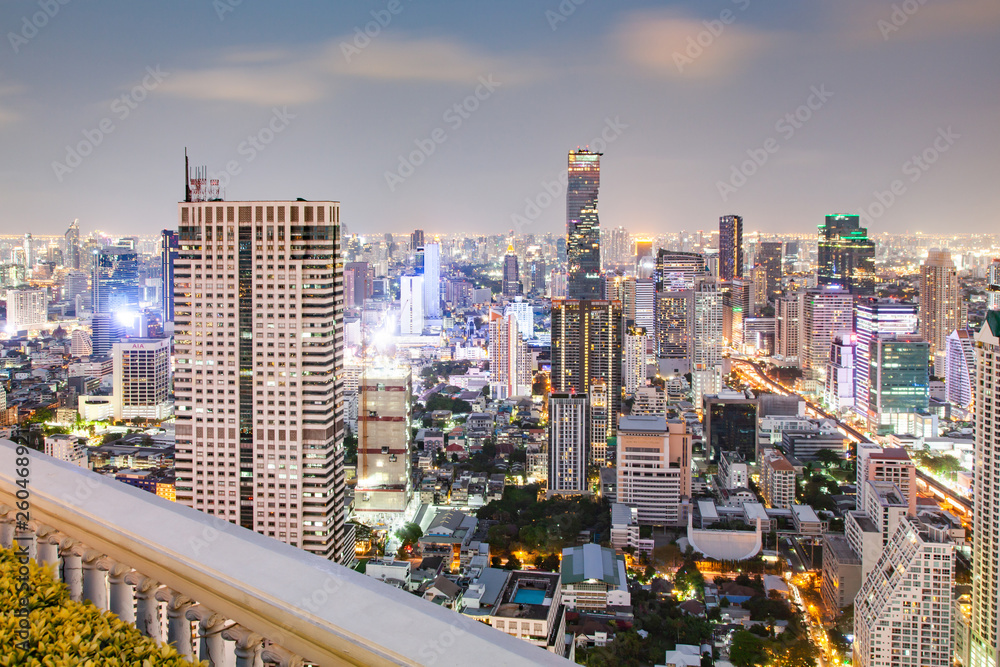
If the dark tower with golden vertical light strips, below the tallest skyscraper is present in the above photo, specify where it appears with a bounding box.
[551,299,624,426]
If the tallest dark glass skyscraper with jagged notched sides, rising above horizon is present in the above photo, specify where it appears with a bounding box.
[566,149,602,299]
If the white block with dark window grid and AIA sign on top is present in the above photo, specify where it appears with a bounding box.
[111,338,173,421]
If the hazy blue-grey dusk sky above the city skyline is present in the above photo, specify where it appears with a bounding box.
[0,0,1000,240]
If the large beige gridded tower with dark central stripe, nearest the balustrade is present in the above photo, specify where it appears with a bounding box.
[174,201,346,561]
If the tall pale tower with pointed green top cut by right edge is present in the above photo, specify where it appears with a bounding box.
[970,310,1000,667]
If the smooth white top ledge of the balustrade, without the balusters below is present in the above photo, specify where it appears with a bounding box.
[0,440,570,666]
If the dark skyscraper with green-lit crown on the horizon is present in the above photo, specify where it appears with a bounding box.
[816,215,875,295]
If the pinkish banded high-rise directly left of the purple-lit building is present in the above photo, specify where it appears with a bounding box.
[799,287,854,386]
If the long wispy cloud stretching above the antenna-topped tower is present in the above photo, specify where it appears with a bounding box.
[162,36,540,106]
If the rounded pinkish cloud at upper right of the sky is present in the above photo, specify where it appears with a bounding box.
[612,5,780,79]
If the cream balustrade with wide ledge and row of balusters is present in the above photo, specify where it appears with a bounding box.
[0,440,569,667]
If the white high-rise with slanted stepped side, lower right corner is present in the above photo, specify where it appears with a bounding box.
[854,518,952,667]
